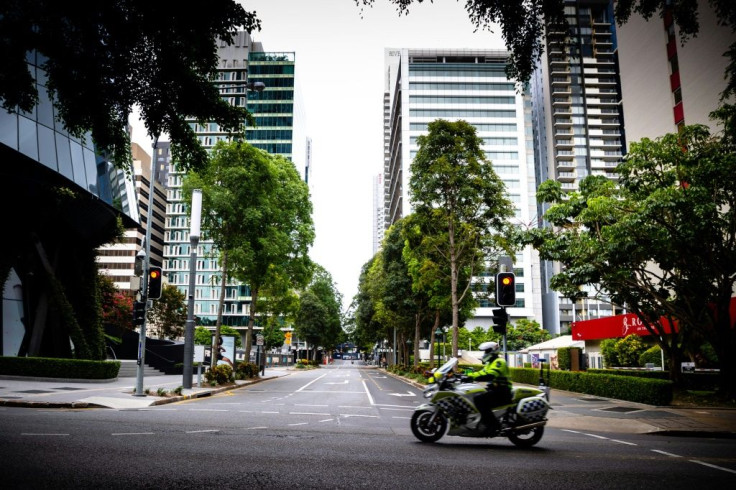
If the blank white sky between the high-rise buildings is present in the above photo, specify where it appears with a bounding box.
[133,0,504,308]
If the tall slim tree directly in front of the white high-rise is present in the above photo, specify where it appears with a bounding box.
[409,119,513,356]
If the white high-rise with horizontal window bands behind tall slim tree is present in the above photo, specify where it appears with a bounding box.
[383,48,542,330]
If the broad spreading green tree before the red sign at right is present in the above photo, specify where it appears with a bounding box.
[527,121,736,398]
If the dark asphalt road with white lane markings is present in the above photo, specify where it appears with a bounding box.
[0,361,736,489]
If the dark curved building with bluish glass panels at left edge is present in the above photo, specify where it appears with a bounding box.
[0,52,137,357]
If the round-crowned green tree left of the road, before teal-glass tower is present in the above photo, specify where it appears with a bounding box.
[183,141,314,366]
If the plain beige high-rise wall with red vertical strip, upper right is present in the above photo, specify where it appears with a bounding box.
[617,2,736,145]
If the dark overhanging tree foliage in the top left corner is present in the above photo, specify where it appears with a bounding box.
[0,0,260,169]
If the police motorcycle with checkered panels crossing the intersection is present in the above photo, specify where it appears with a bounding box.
[411,357,551,448]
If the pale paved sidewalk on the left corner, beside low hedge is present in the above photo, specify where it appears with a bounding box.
[0,367,289,410]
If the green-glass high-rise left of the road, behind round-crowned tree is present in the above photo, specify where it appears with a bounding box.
[164,32,311,332]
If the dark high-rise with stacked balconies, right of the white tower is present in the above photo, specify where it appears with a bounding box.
[531,0,625,334]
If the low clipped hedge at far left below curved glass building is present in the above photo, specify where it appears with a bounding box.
[0,357,120,379]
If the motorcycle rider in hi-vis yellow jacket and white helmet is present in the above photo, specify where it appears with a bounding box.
[461,342,511,430]
